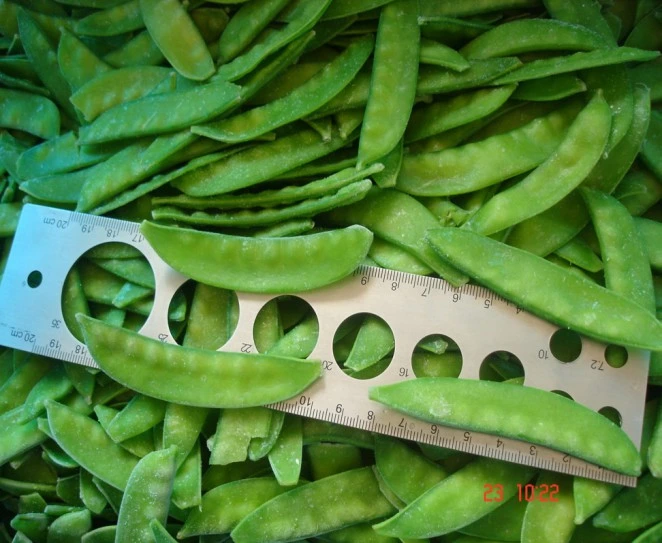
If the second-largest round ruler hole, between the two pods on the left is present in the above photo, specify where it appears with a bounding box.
[168,280,239,351]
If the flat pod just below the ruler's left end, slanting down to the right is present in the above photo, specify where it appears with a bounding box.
[46,401,139,490]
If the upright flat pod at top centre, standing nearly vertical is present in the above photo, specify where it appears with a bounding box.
[358,0,420,168]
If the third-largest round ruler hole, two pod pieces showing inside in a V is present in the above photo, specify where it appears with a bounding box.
[253,296,319,358]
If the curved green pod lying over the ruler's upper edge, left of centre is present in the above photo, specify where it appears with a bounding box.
[141,221,372,292]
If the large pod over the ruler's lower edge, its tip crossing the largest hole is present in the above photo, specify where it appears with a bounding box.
[78,315,320,408]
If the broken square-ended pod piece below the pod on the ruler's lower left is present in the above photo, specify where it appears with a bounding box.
[209,407,271,465]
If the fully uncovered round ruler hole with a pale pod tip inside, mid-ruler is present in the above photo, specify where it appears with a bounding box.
[333,313,396,379]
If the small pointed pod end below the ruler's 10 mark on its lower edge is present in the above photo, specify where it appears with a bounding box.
[268,415,303,487]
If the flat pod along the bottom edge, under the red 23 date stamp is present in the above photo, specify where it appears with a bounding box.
[374,456,534,539]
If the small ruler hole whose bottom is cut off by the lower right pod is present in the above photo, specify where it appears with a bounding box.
[411,334,462,377]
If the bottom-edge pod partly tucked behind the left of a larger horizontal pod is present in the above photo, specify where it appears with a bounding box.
[177,477,289,538]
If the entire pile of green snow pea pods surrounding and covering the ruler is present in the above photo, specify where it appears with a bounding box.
[0,0,662,543]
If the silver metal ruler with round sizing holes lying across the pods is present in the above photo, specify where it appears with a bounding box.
[0,204,649,486]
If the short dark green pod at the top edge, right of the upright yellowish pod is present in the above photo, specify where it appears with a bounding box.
[218,0,288,63]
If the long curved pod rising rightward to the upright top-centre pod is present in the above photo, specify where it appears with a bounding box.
[191,37,372,143]
